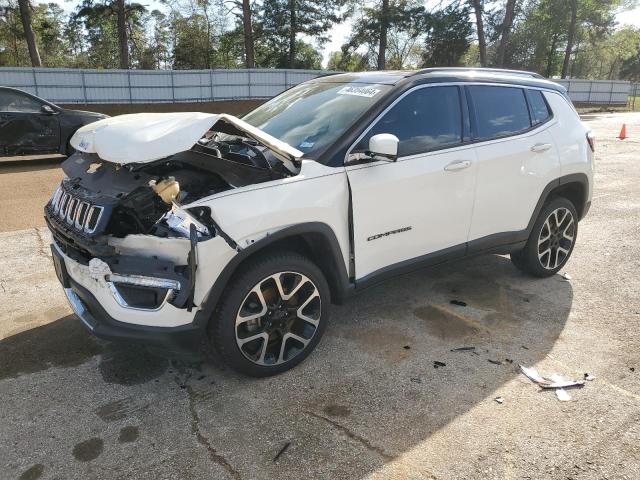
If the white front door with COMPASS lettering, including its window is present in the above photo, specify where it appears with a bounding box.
[346,85,475,280]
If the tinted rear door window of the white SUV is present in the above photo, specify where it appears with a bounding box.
[468,85,531,140]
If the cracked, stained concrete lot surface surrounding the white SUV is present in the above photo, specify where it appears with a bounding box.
[0,110,640,480]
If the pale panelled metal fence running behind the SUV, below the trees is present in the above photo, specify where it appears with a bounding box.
[0,67,631,105]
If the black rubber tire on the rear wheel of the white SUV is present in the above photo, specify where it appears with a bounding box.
[511,197,578,278]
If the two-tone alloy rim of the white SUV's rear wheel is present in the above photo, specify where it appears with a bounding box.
[538,207,576,270]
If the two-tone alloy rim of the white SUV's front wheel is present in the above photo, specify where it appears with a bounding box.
[235,271,322,366]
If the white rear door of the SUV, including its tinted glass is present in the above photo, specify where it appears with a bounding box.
[466,85,560,246]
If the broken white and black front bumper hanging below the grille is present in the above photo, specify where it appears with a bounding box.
[51,230,237,351]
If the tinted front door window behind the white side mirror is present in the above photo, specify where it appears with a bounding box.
[355,87,462,157]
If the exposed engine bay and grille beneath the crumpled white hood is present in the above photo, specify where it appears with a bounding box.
[51,131,292,244]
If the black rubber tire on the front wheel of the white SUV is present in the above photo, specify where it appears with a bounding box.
[208,252,330,377]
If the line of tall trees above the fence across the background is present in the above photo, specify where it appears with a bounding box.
[0,0,640,80]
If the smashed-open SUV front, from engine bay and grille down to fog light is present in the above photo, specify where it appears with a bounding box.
[45,125,295,311]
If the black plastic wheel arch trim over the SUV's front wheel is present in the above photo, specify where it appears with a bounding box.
[194,222,352,325]
